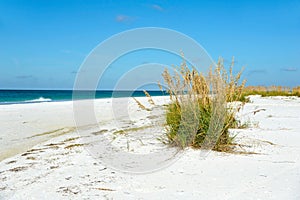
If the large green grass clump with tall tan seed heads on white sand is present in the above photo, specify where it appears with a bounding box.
[163,56,245,151]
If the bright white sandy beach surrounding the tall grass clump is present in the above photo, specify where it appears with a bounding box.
[0,96,300,200]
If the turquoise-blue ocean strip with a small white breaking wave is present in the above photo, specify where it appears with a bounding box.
[0,90,167,105]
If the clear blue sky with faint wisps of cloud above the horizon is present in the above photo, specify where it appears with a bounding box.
[0,0,300,89]
